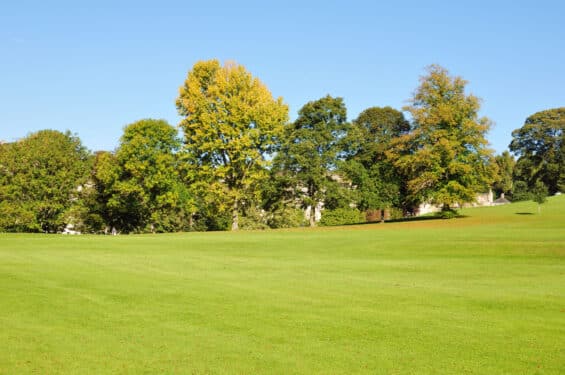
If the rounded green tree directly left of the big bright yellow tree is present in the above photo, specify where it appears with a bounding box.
[90,119,191,232]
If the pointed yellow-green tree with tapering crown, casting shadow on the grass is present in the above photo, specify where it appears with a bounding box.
[389,65,495,210]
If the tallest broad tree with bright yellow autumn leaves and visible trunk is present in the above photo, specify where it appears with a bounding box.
[176,60,288,230]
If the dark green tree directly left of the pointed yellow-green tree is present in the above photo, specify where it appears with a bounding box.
[341,107,410,216]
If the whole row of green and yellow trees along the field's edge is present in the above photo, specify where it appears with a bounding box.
[0,60,565,233]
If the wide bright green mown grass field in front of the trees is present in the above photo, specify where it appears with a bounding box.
[0,196,565,374]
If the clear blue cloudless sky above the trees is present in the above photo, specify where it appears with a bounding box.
[0,0,565,152]
